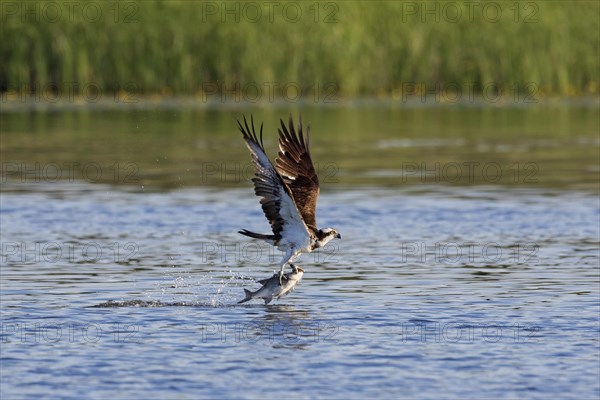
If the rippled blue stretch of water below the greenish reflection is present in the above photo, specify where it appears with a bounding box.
[0,182,600,399]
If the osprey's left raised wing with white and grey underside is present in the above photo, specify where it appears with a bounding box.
[238,116,310,242]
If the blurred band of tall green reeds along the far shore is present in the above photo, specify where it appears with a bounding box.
[0,1,600,96]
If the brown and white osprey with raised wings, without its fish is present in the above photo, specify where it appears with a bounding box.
[238,115,341,280]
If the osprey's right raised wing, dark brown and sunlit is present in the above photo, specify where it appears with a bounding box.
[275,115,319,232]
